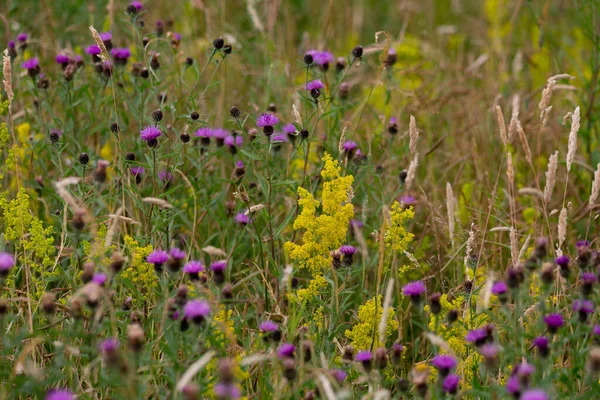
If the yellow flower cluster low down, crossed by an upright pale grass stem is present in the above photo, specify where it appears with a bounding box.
[345,295,398,350]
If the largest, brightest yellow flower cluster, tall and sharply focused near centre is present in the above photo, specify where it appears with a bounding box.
[285,153,354,273]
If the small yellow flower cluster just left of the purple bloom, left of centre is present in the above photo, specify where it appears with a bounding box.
[121,235,158,303]
